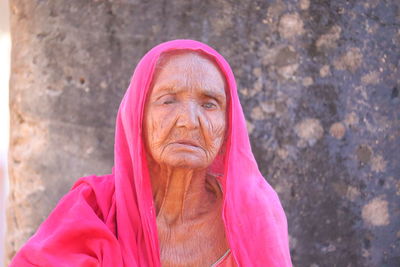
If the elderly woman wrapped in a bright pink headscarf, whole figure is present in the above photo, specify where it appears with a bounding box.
[11,40,291,267]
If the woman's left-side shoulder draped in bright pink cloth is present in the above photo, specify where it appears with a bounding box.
[10,175,120,267]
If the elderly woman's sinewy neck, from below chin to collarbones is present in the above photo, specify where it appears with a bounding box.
[150,166,221,225]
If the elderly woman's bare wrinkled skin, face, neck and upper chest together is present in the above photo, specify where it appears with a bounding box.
[144,52,228,266]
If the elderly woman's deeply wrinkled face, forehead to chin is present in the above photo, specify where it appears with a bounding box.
[144,52,227,169]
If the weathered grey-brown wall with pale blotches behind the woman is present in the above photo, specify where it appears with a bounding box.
[8,0,400,267]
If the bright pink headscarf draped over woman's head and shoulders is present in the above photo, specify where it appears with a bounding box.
[11,40,292,267]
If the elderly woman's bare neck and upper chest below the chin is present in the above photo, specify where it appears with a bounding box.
[149,166,229,267]
